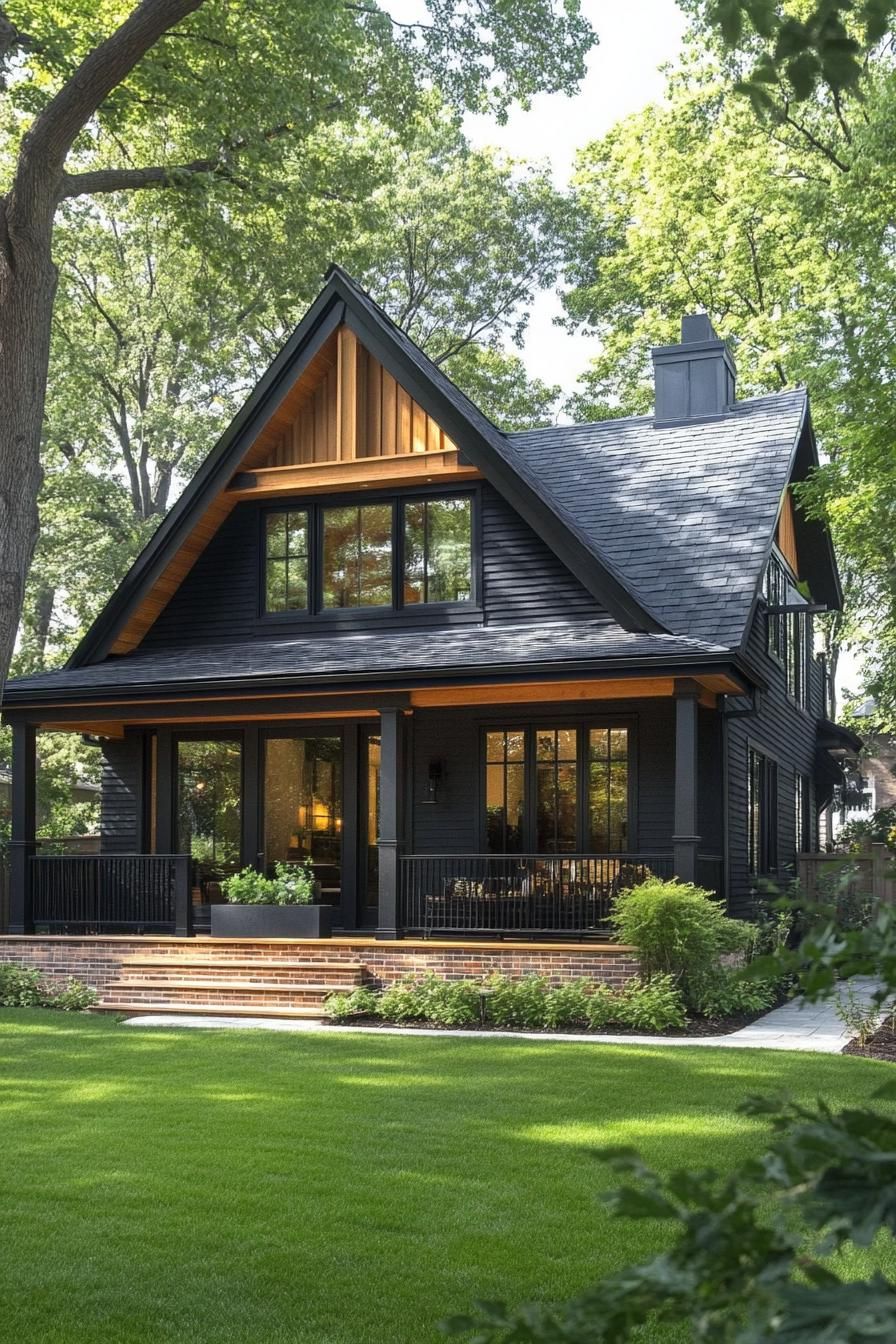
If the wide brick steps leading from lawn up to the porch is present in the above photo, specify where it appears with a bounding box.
[97,953,368,1017]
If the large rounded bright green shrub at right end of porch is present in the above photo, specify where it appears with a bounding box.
[610,878,751,997]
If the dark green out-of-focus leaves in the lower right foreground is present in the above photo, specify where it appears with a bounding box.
[446,907,896,1344]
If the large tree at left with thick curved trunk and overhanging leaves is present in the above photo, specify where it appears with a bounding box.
[0,0,592,687]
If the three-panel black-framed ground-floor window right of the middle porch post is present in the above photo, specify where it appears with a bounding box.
[482,722,633,853]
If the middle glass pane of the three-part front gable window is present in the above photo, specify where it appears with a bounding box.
[324,504,392,607]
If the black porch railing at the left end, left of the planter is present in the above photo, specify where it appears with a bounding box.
[28,853,192,934]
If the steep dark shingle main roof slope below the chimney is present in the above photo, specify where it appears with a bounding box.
[506,391,806,648]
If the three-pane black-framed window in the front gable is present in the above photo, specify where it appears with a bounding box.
[263,493,477,616]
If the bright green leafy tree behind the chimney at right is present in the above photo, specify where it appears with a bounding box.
[567,36,896,718]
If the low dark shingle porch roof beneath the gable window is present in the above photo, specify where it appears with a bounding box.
[7,620,724,704]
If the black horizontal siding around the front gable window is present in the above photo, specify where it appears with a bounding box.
[142,485,609,649]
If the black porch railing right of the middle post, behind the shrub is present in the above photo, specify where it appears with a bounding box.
[399,853,673,937]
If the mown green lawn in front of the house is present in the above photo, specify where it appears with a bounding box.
[0,1009,889,1344]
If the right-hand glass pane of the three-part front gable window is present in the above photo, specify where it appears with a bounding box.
[404,496,473,603]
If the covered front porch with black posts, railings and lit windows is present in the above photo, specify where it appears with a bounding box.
[7,669,743,941]
